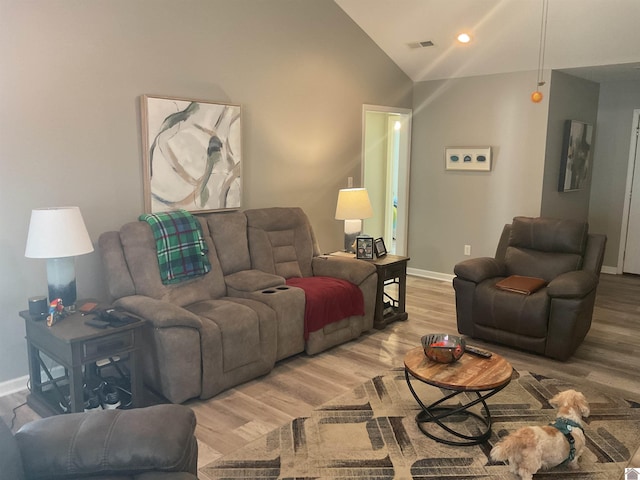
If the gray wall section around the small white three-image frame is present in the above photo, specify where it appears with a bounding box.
[408,72,548,274]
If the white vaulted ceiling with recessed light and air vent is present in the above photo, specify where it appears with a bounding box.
[335,0,640,82]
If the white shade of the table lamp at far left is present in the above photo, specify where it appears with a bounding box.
[24,207,93,258]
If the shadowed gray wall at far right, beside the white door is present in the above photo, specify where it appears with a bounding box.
[589,81,640,267]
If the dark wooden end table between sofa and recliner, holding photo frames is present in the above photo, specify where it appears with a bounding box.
[363,254,410,329]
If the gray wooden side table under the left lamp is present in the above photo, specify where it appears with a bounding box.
[20,310,144,417]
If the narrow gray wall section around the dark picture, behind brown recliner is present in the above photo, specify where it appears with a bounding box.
[540,71,600,220]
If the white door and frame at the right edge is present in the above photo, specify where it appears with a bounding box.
[618,110,640,275]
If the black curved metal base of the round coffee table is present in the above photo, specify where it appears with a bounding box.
[404,369,508,447]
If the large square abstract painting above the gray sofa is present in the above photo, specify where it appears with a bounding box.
[141,95,242,213]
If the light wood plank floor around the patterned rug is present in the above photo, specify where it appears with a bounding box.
[0,274,640,480]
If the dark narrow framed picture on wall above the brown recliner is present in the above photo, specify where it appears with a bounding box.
[558,120,593,192]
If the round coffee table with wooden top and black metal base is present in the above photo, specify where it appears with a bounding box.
[404,347,513,446]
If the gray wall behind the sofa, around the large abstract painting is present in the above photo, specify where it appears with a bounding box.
[0,0,412,382]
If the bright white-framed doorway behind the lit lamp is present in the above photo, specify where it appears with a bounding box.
[362,105,412,255]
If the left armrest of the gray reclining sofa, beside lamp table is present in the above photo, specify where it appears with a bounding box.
[114,295,202,328]
